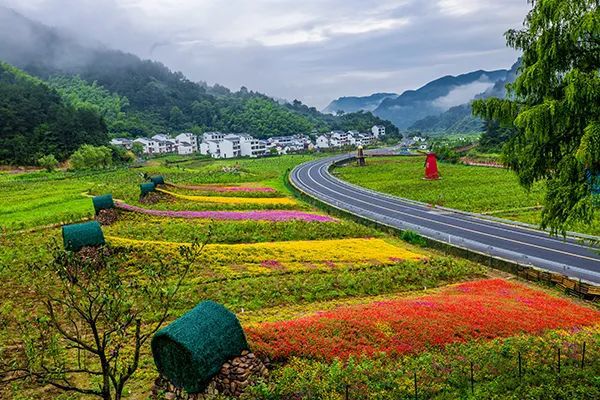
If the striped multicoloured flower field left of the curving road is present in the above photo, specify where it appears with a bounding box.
[0,156,600,399]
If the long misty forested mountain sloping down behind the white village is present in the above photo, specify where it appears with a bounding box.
[0,7,404,138]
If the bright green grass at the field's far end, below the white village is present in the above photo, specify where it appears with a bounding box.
[0,155,314,230]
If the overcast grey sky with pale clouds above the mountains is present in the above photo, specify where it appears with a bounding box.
[0,0,528,108]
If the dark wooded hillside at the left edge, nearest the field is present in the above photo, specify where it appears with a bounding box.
[0,62,108,165]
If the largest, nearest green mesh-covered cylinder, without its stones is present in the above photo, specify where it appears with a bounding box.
[152,301,248,393]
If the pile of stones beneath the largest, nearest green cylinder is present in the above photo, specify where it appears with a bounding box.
[152,350,269,400]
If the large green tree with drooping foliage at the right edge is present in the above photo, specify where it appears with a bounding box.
[473,0,600,233]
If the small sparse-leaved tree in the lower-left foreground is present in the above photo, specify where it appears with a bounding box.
[0,239,210,400]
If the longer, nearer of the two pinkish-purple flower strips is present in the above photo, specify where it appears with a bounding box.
[115,202,337,222]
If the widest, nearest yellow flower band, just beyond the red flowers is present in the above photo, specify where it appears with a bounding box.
[106,236,425,274]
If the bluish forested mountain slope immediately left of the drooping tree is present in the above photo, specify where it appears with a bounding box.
[408,60,521,134]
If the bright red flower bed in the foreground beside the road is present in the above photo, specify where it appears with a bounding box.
[246,279,600,360]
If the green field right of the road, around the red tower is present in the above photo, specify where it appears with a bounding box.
[334,157,600,235]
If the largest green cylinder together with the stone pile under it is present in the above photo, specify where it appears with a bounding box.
[152,301,267,399]
